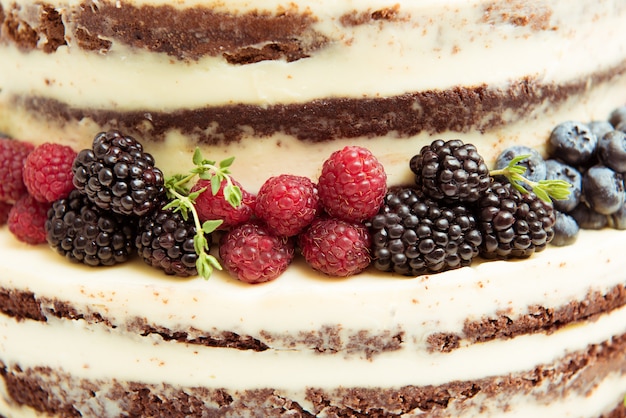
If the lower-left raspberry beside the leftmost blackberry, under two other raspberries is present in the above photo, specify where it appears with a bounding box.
[8,194,50,245]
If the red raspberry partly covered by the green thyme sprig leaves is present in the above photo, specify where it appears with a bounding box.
[191,179,256,230]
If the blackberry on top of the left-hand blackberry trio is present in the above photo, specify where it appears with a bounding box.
[72,131,165,216]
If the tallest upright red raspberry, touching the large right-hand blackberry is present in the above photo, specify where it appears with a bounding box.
[318,146,387,222]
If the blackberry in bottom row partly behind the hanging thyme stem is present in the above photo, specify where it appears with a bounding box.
[135,203,198,277]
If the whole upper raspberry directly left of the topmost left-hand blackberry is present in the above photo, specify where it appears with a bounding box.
[23,143,76,202]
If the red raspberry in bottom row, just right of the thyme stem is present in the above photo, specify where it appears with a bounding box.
[220,223,294,284]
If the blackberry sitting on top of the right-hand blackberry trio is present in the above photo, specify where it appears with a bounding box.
[410,139,491,202]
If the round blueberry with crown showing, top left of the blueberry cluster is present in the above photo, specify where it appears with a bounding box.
[548,121,598,166]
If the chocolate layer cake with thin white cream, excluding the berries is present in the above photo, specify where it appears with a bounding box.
[0,0,626,418]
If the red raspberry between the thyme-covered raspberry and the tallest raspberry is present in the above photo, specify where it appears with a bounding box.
[255,174,319,237]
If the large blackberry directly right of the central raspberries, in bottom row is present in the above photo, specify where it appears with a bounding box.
[370,188,481,276]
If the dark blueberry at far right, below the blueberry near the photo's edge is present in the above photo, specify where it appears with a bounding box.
[583,165,624,215]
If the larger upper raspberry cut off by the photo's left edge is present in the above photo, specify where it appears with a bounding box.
[0,138,35,203]
